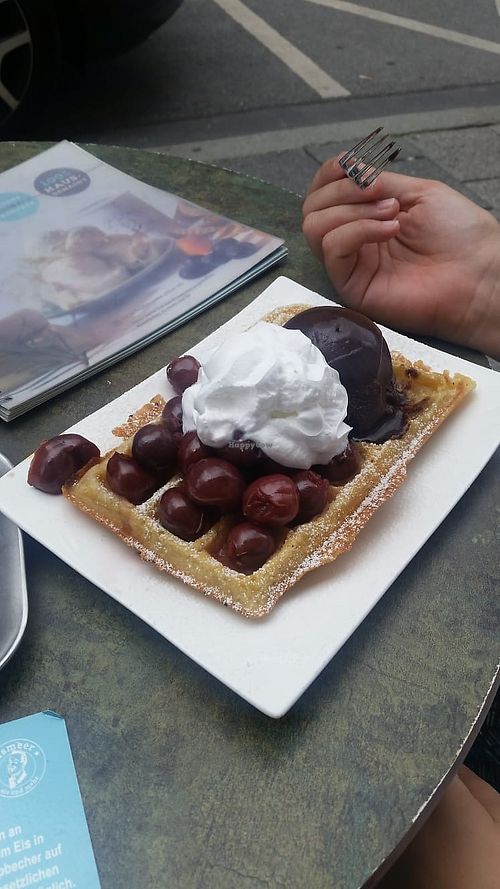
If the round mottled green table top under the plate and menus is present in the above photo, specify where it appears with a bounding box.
[0,143,500,889]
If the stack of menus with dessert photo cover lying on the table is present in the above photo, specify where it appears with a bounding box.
[0,142,286,420]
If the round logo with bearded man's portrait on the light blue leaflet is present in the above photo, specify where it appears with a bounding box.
[0,738,47,798]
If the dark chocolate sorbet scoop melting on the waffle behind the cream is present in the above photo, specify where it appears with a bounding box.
[285,306,406,443]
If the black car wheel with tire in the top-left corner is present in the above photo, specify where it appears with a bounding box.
[0,0,61,135]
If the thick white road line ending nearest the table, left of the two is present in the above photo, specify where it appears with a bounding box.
[213,0,350,99]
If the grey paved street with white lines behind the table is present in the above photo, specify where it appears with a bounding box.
[18,0,500,217]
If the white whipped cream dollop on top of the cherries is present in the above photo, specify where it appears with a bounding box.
[182,321,350,469]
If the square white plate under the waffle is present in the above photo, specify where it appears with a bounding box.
[0,277,500,717]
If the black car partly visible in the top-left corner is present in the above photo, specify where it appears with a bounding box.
[0,0,182,125]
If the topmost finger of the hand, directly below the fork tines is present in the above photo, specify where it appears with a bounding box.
[302,173,424,215]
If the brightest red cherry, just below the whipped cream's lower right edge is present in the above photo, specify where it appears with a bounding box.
[243,474,299,525]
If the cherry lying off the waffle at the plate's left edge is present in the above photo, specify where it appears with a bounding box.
[28,432,100,494]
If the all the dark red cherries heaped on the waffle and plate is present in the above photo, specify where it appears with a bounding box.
[28,355,359,574]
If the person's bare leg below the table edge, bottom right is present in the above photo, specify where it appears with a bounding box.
[378,766,500,889]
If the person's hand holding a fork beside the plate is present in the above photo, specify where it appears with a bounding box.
[303,158,500,357]
